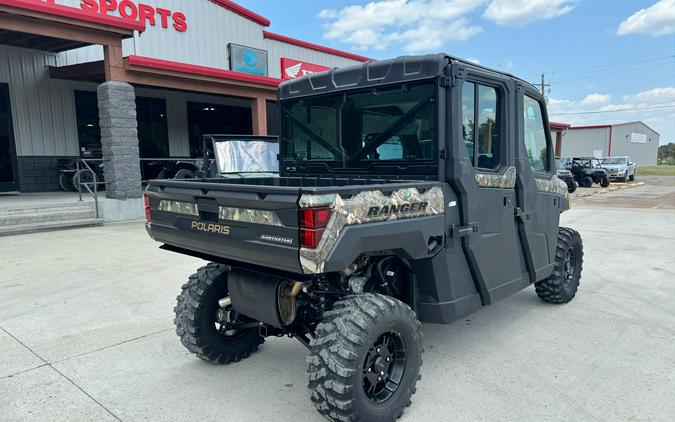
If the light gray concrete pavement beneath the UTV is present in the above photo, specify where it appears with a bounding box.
[0,180,675,421]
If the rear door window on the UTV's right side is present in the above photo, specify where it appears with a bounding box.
[462,82,501,170]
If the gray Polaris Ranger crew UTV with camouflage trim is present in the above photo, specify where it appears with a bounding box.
[146,55,583,421]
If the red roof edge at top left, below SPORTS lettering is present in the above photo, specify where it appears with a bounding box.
[0,0,145,31]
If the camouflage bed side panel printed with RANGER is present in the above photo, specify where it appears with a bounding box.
[300,185,445,274]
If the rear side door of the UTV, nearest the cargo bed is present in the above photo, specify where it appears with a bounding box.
[453,69,529,304]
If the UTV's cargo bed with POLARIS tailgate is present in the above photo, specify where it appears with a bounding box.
[146,177,438,274]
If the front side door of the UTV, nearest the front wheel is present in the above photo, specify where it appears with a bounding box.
[516,84,566,283]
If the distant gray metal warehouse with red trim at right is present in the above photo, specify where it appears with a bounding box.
[554,122,660,166]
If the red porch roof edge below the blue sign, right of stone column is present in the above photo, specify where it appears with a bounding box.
[127,56,282,87]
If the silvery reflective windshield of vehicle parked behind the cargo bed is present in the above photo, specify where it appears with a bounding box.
[213,139,279,174]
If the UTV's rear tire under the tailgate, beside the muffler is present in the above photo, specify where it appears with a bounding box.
[174,263,265,364]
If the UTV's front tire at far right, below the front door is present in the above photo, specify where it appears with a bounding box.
[535,227,584,304]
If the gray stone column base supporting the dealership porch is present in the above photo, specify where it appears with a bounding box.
[98,81,143,199]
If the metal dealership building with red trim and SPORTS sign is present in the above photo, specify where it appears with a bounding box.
[0,0,369,207]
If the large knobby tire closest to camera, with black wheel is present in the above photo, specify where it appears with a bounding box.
[306,293,423,422]
